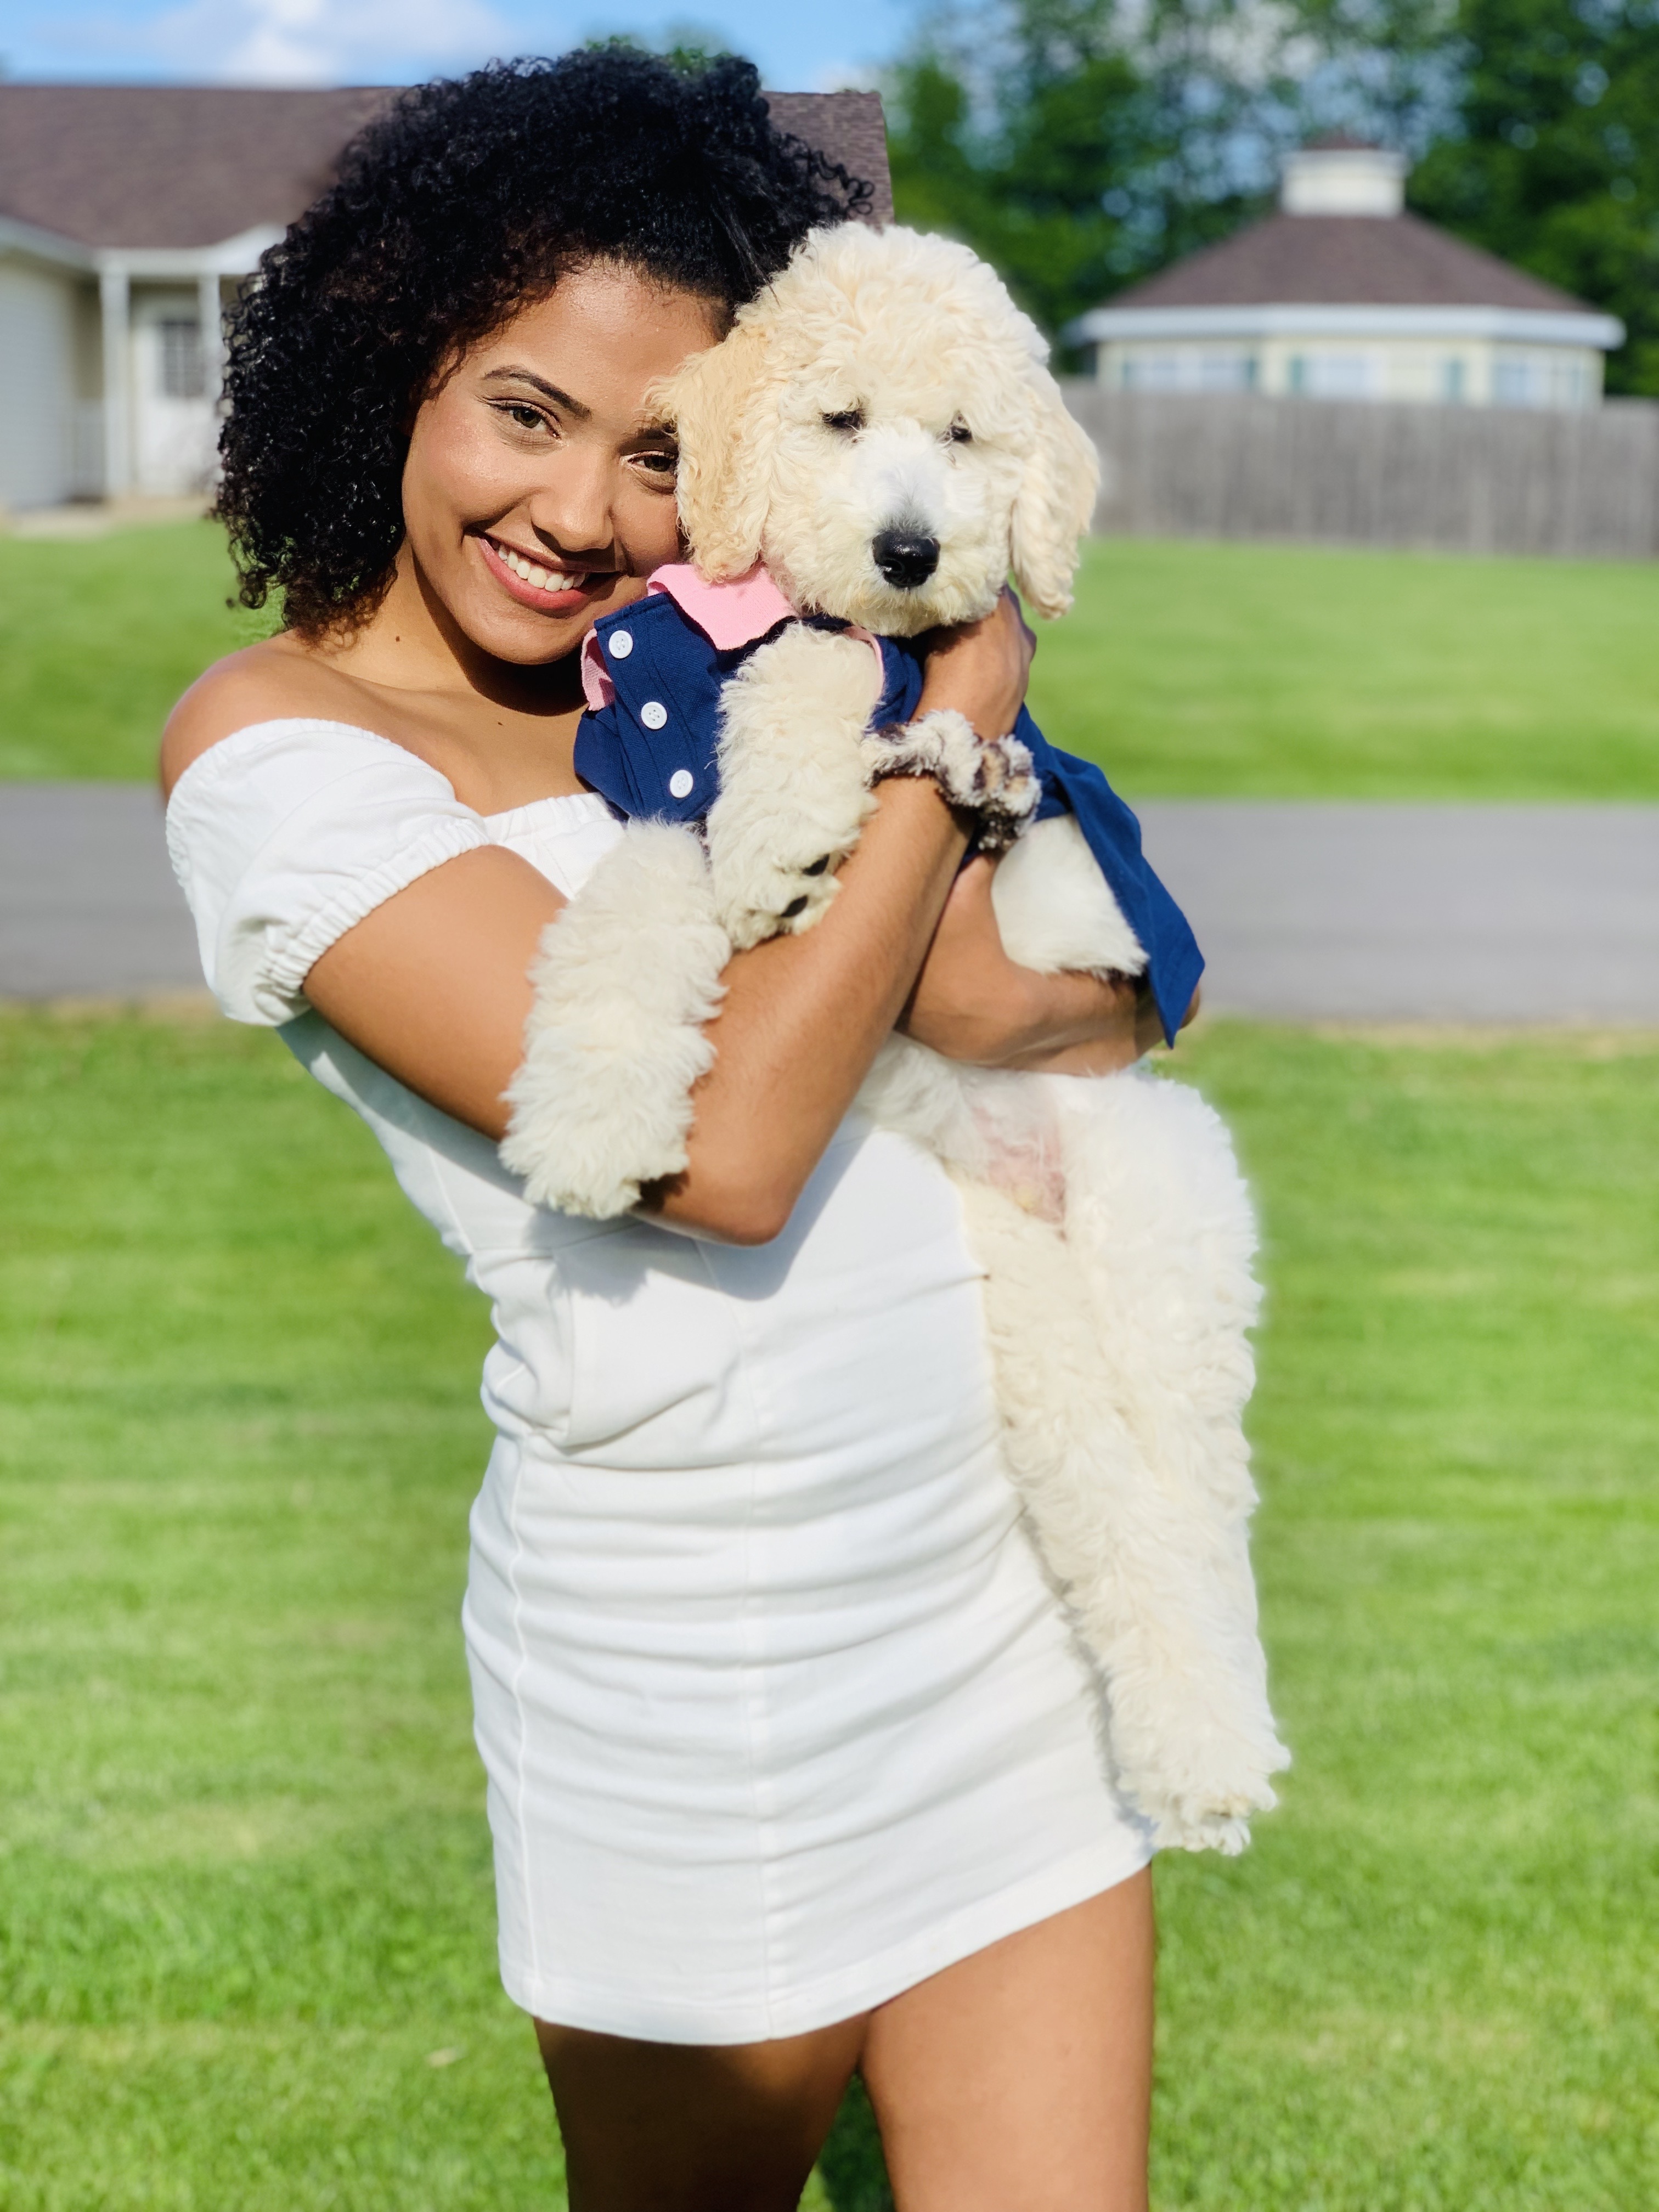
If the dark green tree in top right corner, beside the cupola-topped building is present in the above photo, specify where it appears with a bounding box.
[1409,0,1659,394]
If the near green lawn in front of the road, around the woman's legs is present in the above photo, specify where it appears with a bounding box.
[0,1013,1659,2212]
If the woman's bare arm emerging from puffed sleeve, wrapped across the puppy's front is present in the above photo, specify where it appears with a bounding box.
[305,600,1031,1243]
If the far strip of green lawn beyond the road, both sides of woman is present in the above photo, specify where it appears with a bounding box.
[0,524,1659,801]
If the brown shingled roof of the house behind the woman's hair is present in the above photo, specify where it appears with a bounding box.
[0,84,894,248]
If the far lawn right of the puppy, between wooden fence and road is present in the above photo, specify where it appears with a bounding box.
[1031,538,1659,801]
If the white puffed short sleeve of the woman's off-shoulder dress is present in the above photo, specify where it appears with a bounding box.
[168,721,491,1029]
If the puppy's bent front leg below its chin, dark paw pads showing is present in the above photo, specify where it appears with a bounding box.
[708,626,881,949]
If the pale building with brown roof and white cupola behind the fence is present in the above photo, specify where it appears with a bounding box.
[1068,139,1623,407]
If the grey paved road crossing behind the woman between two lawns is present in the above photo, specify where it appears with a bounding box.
[0,783,1659,1026]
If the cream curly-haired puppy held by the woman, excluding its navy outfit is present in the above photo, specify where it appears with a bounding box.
[502,223,1288,1852]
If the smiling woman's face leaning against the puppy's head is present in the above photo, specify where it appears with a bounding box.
[403,263,721,666]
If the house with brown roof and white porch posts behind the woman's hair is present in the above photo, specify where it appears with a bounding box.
[0,84,891,509]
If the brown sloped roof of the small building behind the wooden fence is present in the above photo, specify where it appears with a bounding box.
[1108,215,1595,314]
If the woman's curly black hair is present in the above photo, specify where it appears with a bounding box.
[215,44,870,635]
